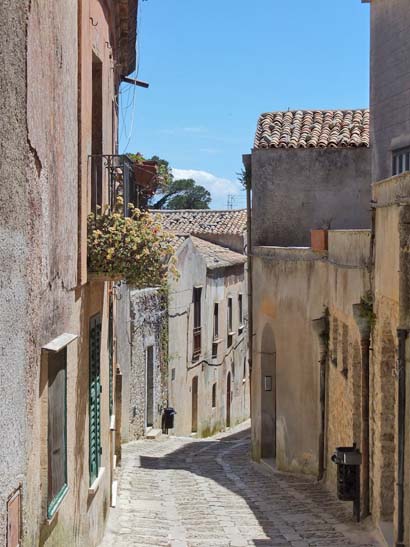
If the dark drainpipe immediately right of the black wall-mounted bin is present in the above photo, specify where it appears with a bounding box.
[353,304,371,518]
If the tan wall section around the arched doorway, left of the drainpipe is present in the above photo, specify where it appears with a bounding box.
[252,248,327,474]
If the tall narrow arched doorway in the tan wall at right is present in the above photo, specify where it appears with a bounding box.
[261,325,276,458]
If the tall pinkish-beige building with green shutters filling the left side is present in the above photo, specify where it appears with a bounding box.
[0,0,137,547]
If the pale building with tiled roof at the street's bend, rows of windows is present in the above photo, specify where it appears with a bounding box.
[154,210,250,436]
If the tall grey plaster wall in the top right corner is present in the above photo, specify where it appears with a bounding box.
[370,0,410,181]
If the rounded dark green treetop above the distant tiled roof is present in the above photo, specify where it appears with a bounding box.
[153,179,211,209]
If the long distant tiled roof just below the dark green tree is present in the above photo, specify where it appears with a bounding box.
[152,209,246,235]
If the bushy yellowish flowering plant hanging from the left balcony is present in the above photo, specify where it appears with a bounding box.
[88,198,174,288]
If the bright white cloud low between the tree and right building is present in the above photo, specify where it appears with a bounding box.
[172,169,245,209]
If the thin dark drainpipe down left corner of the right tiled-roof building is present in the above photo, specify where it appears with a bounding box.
[242,154,253,402]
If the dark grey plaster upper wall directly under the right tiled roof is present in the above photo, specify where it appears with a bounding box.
[252,148,371,246]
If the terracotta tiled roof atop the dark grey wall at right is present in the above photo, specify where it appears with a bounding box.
[254,110,370,148]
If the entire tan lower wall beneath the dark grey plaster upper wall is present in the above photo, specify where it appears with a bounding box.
[252,230,370,489]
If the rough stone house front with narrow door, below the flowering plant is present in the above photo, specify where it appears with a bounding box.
[117,285,168,442]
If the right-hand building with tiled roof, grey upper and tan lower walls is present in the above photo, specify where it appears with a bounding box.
[244,110,371,497]
